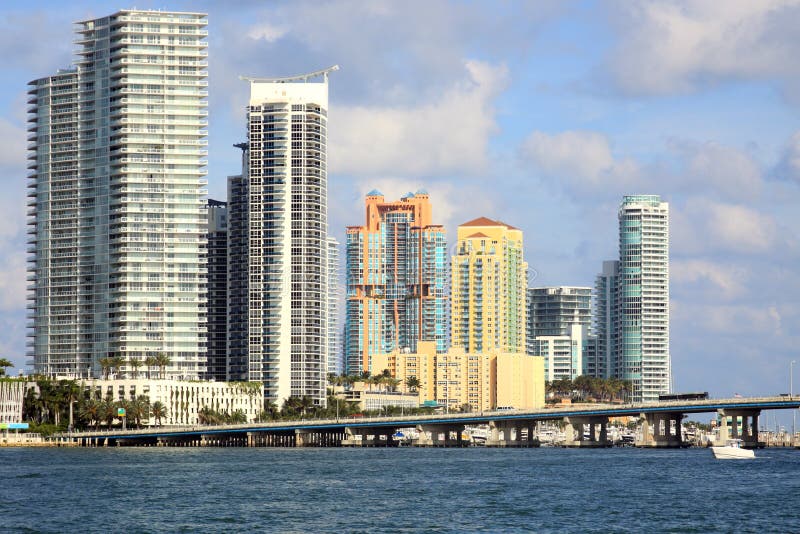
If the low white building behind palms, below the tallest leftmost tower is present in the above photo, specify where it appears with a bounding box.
[81,378,264,426]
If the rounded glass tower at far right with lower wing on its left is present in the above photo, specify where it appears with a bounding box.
[595,195,671,402]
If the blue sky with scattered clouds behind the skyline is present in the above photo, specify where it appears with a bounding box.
[0,0,800,406]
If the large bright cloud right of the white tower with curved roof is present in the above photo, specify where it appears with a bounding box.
[329,61,508,177]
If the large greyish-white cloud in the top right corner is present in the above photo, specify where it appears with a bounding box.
[611,0,800,94]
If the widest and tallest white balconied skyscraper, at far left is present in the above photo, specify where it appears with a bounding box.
[28,10,208,378]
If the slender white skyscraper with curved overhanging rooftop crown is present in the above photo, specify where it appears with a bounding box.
[239,67,338,405]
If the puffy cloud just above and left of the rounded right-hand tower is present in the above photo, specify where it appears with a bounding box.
[521,131,639,194]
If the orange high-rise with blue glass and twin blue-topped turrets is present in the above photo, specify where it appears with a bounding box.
[344,190,447,373]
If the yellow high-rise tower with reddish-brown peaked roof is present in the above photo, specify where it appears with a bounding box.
[451,217,528,353]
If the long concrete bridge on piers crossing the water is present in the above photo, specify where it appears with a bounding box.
[62,396,800,447]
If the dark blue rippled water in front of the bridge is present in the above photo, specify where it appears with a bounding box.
[0,448,800,533]
